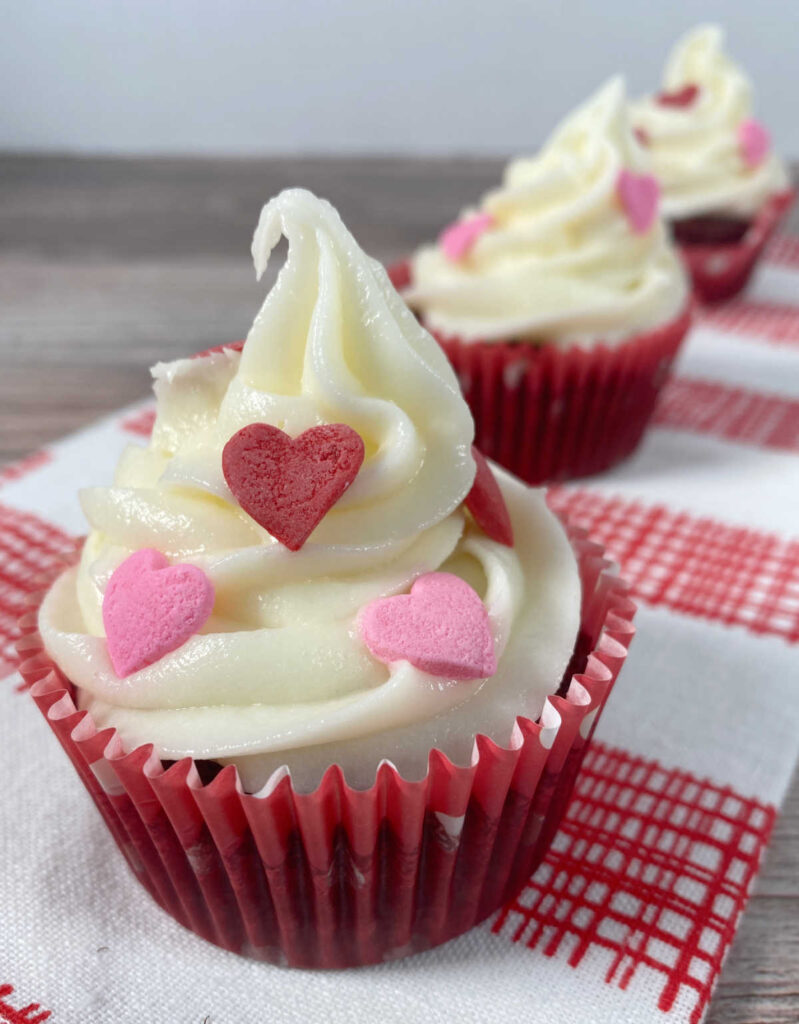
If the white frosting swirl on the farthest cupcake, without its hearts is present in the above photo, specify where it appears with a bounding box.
[630,25,788,220]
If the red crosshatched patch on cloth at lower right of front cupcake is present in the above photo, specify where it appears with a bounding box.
[493,742,776,1022]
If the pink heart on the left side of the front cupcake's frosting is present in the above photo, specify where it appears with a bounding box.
[102,548,214,679]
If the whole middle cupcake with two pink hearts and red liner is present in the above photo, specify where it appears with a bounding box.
[391,78,689,483]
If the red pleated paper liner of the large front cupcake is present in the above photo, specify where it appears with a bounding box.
[18,527,634,968]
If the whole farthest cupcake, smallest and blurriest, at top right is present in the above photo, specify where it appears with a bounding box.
[631,26,794,301]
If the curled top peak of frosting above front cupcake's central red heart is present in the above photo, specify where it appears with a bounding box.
[235,188,474,543]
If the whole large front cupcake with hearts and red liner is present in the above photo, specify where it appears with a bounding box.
[15,189,631,967]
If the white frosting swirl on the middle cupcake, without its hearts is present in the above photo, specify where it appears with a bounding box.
[405,78,686,345]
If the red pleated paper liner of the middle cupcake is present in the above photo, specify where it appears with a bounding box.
[388,262,690,484]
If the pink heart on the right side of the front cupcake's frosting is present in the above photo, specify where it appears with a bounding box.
[360,572,497,679]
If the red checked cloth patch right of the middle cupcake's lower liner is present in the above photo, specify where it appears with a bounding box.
[653,377,799,452]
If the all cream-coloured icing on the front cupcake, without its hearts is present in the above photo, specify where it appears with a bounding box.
[39,189,580,790]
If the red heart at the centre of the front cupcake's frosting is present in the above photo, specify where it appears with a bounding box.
[222,423,364,551]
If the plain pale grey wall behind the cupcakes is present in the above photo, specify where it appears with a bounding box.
[0,0,799,157]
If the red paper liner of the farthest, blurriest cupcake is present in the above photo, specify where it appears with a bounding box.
[679,189,796,303]
